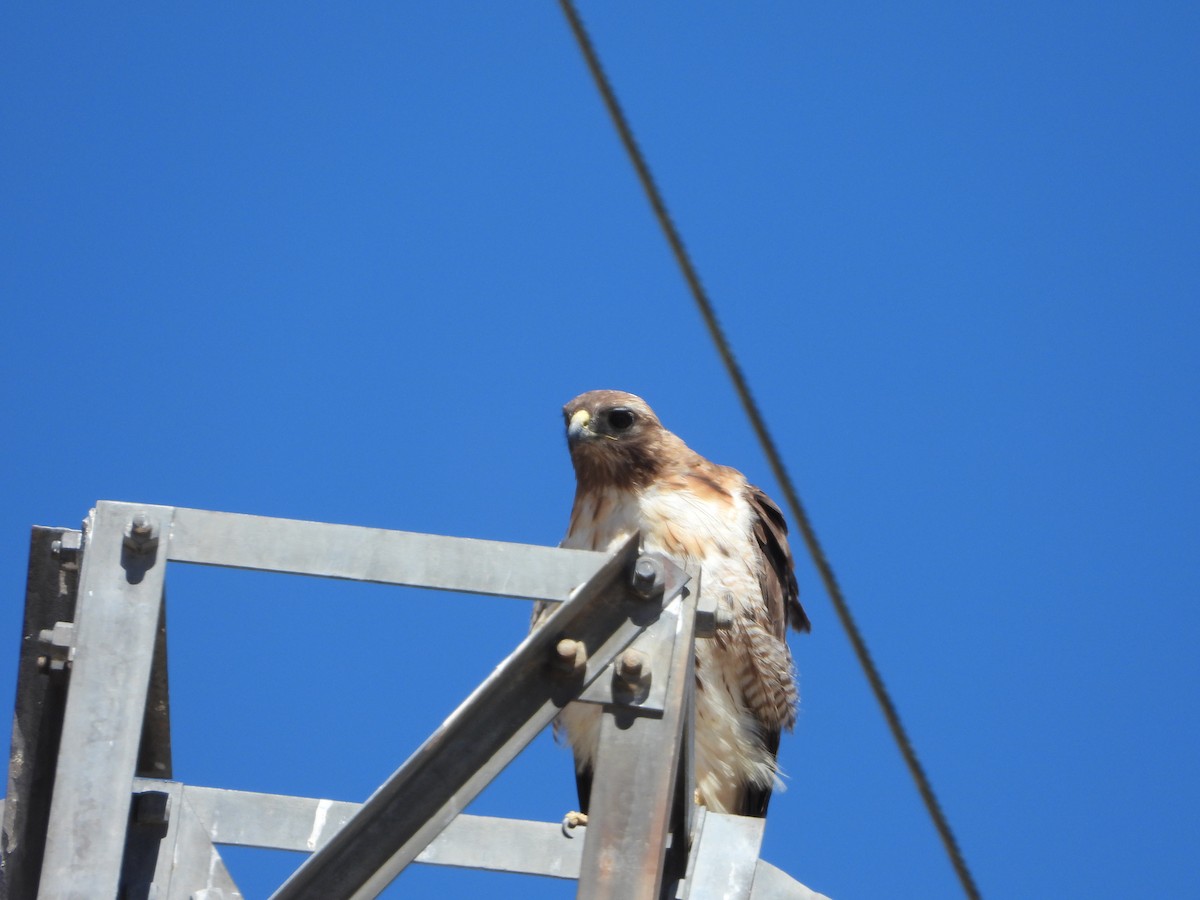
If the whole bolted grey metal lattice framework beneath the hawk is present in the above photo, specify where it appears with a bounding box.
[0,502,818,900]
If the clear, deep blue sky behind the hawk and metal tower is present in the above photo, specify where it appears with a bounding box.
[0,0,1200,900]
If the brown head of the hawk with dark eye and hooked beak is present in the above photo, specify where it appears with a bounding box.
[563,390,678,490]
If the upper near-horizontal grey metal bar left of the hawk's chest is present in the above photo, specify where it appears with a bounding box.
[167,506,607,600]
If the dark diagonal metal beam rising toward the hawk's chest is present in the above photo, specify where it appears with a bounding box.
[267,535,684,900]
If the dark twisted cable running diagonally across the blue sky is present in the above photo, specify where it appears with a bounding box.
[558,0,979,900]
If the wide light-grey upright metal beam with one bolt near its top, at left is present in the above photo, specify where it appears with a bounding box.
[40,503,170,900]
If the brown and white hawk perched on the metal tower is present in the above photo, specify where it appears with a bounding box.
[542,390,809,816]
